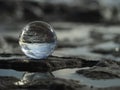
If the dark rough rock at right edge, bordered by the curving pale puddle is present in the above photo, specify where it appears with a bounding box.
[77,60,120,79]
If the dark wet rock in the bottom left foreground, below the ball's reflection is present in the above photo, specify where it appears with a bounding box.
[0,77,83,90]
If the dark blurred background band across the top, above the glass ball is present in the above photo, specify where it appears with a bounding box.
[0,0,120,25]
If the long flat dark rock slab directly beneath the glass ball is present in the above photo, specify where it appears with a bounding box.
[0,56,98,72]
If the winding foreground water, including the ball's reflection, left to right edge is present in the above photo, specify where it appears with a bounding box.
[0,67,120,87]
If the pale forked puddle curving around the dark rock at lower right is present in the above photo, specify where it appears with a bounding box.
[53,67,120,88]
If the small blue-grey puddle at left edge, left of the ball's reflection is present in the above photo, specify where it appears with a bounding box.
[0,69,25,79]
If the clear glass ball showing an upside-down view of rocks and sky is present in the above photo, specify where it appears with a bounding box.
[19,21,57,59]
